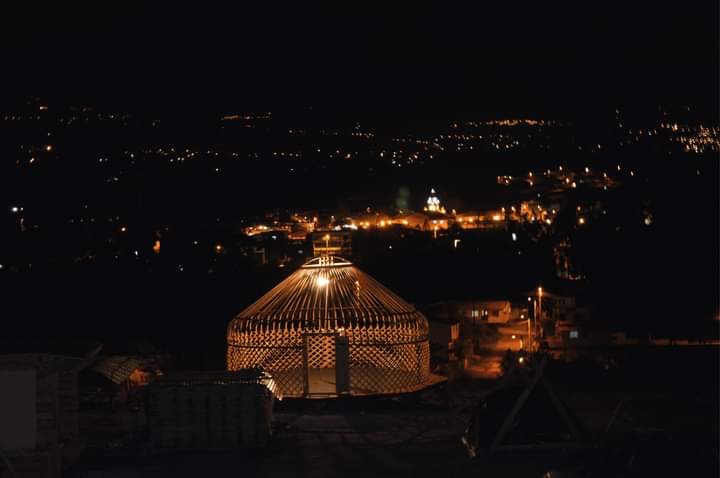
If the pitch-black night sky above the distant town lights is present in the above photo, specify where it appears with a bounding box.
[0,0,718,117]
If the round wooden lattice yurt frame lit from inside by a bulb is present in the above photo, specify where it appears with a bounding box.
[227,256,439,397]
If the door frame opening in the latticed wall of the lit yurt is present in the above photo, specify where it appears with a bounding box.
[303,332,350,397]
